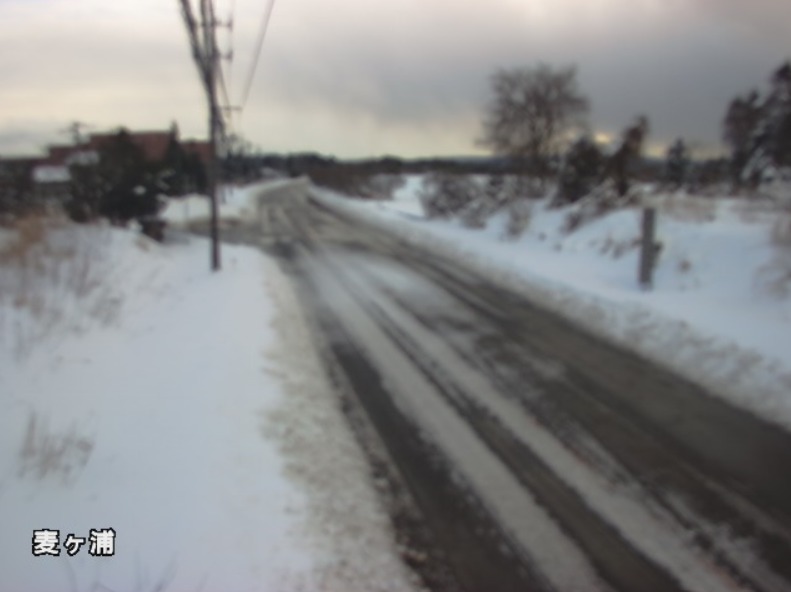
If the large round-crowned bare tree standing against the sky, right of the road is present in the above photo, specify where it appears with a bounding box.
[481,64,589,180]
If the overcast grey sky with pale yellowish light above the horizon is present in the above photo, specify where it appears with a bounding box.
[0,0,791,157]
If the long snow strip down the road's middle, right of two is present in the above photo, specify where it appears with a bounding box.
[336,251,740,592]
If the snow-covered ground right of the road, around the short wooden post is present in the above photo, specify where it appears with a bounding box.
[315,176,791,427]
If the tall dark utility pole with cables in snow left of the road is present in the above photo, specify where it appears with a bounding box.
[179,0,224,271]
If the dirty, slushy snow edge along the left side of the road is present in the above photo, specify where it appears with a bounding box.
[266,243,418,592]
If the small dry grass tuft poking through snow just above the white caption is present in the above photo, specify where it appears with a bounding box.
[19,412,94,484]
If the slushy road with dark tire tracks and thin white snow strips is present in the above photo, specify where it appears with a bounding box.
[213,181,791,592]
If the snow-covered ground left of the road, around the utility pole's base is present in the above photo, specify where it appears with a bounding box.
[0,201,414,592]
